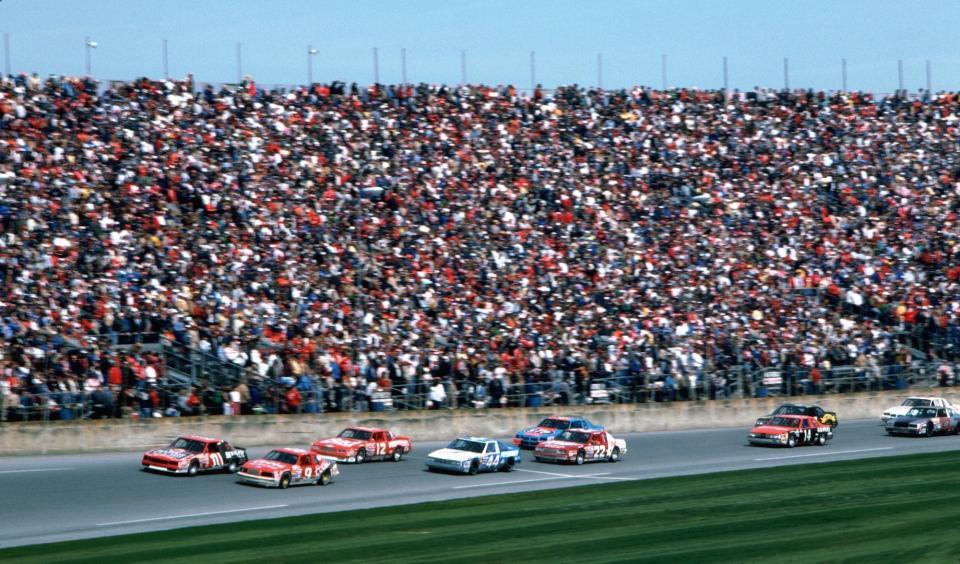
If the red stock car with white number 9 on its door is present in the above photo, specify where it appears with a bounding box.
[237,448,340,489]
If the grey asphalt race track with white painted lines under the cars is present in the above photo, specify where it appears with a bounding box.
[0,420,960,547]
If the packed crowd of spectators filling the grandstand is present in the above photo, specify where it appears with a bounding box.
[0,75,960,413]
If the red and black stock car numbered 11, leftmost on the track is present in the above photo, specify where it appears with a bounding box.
[140,436,247,476]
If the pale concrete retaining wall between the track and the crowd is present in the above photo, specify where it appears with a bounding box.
[0,389,960,456]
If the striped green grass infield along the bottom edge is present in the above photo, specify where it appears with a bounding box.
[0,451,960,564]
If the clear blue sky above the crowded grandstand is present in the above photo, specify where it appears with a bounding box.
[0,0,960,92]
